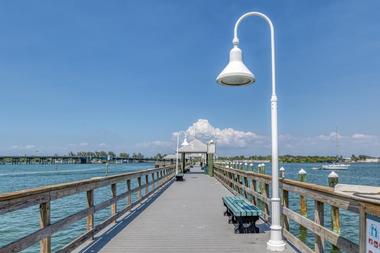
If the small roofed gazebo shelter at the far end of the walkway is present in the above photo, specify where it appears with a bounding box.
[178,139,215,176]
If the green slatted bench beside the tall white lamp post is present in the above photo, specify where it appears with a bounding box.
[222,196,262,233]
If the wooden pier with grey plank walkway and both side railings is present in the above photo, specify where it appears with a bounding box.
[0,163,380,253]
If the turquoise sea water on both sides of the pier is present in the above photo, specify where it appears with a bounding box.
[0,163,380,252]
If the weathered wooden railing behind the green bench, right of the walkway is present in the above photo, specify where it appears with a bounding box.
[214,164,380,253]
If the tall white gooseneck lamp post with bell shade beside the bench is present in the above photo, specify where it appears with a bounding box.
[216,12,285,251]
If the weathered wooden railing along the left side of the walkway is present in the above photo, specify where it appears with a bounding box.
[0,167,175,253]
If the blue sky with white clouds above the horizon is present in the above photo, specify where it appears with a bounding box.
[0,0,380,156]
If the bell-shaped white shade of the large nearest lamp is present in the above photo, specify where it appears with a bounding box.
[216,46,256,86]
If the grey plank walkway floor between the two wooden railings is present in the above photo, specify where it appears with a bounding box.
[81,167,296,253]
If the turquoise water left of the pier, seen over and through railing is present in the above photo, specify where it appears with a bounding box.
[0,163,154,252]
